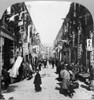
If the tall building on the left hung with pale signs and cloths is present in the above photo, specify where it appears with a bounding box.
[0,2,39,69]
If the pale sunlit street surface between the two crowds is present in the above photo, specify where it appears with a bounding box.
[3,65,94,100]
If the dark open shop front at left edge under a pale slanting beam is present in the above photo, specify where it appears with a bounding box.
[0,28,14,70]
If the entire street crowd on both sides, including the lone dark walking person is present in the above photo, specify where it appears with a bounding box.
[1,57,94,97]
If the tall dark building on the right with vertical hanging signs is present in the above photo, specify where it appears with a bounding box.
[53,3,93,67]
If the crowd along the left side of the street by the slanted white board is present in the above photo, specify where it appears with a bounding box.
[1,56,47,90]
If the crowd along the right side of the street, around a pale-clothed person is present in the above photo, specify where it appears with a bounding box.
[52,60,94,98]
